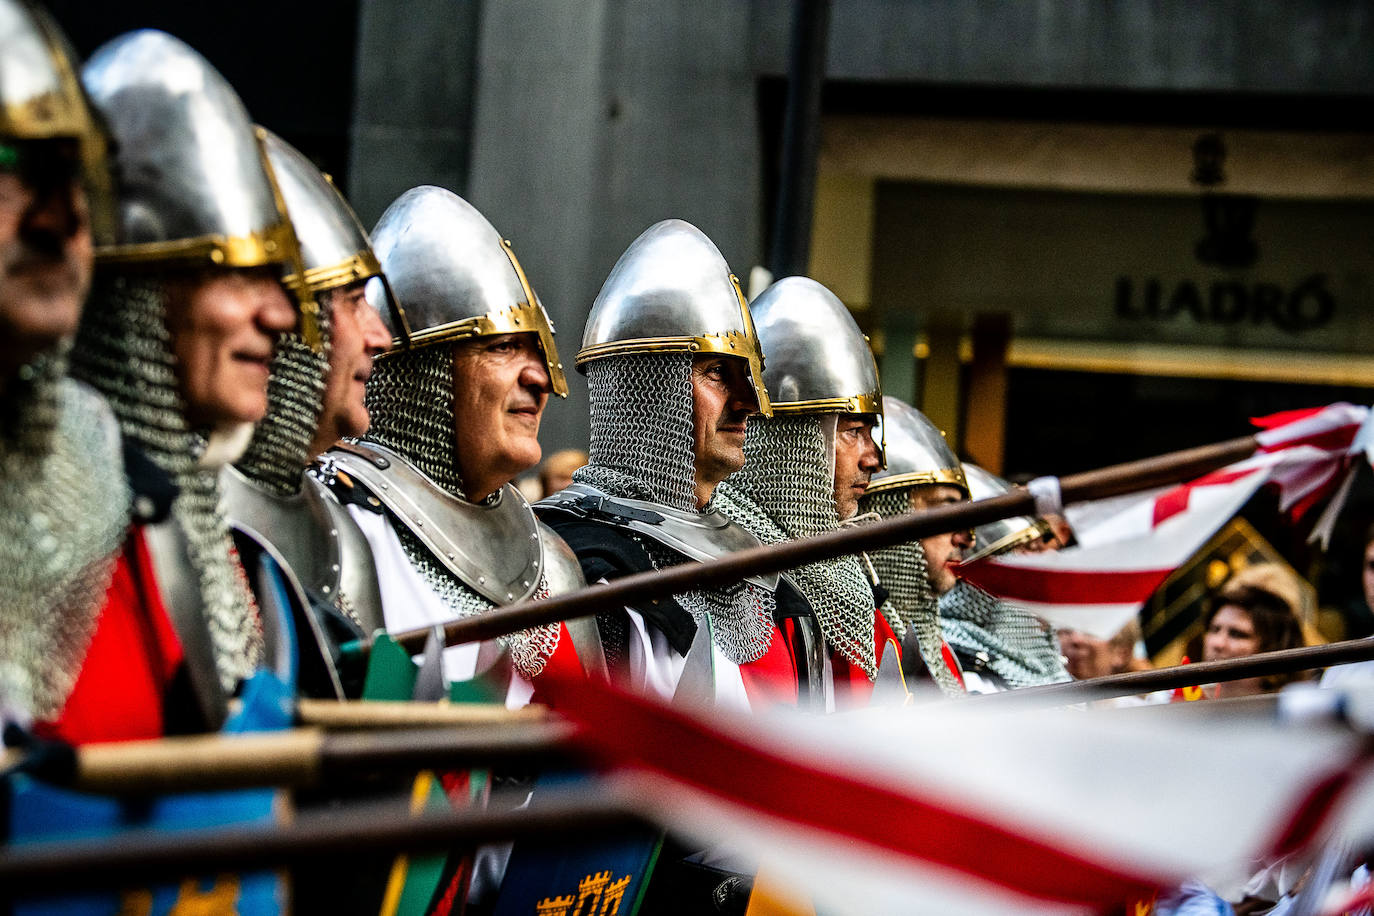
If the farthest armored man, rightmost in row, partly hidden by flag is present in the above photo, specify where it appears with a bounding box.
[940,463,1072,694]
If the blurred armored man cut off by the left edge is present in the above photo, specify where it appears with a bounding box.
[0,0,158,740]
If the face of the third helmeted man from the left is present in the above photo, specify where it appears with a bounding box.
[311,280,392,455]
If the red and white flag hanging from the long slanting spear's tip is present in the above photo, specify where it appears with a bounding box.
[959,404,1371,639]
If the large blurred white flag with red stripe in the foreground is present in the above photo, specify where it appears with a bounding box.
[559,672,1374,916]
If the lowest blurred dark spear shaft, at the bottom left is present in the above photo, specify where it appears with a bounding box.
[0,798,644,900]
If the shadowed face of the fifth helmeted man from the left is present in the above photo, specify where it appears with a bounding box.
[691,353,758,508]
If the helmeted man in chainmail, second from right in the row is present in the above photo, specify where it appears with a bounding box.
[860,397,973,696]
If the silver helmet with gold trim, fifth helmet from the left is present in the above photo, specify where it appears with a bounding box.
[577,220,772,416]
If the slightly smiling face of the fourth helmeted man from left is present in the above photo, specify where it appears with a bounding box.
[453,332,551,503]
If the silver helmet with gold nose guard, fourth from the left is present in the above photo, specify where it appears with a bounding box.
[370,185,567,397]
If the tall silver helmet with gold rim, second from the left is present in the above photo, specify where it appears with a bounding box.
[81,29,300,273]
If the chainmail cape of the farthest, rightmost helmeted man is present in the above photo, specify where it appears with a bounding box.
[940,581,1073,688]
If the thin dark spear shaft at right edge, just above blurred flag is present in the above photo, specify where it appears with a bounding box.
[969,639,1374,706]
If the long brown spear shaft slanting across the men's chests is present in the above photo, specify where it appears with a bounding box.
[359,435,1257,654]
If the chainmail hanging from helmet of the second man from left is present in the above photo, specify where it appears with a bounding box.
[71,272,264,692]
